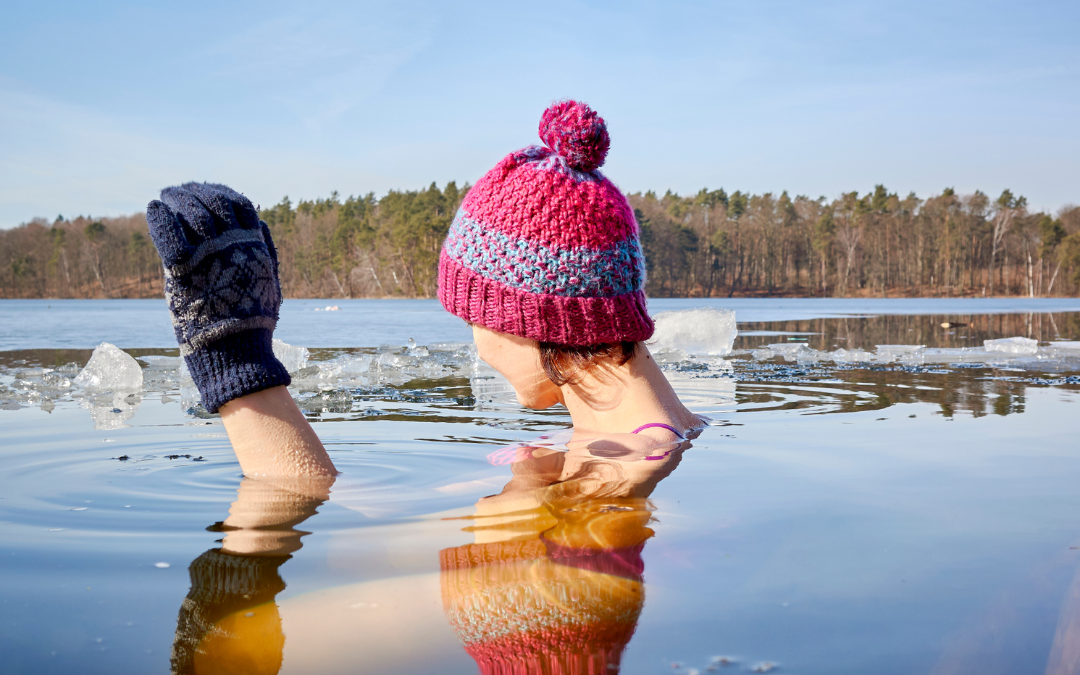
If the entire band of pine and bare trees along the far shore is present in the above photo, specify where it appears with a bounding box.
[0,183,1080,298]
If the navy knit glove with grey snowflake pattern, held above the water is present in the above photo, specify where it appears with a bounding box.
[146,183,289,413]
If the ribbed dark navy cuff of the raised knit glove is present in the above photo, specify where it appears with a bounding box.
[185,328,292,413]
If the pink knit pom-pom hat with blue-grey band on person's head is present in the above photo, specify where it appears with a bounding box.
[438,100,653,345]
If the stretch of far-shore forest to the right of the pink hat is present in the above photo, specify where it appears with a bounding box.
[630,185,1080,297]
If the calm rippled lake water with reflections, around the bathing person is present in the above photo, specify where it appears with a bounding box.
[0,299,1080,675]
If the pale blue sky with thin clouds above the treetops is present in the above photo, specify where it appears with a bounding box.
[0,0,1080,227]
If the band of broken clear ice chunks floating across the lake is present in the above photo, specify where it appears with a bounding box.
[0,307,1080,429]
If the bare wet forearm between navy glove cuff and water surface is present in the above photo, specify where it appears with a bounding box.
[220,387,337,476]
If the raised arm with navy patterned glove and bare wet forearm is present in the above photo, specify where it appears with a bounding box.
[147,183,337,476]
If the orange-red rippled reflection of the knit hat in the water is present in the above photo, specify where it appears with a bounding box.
[440,539,645,675]
